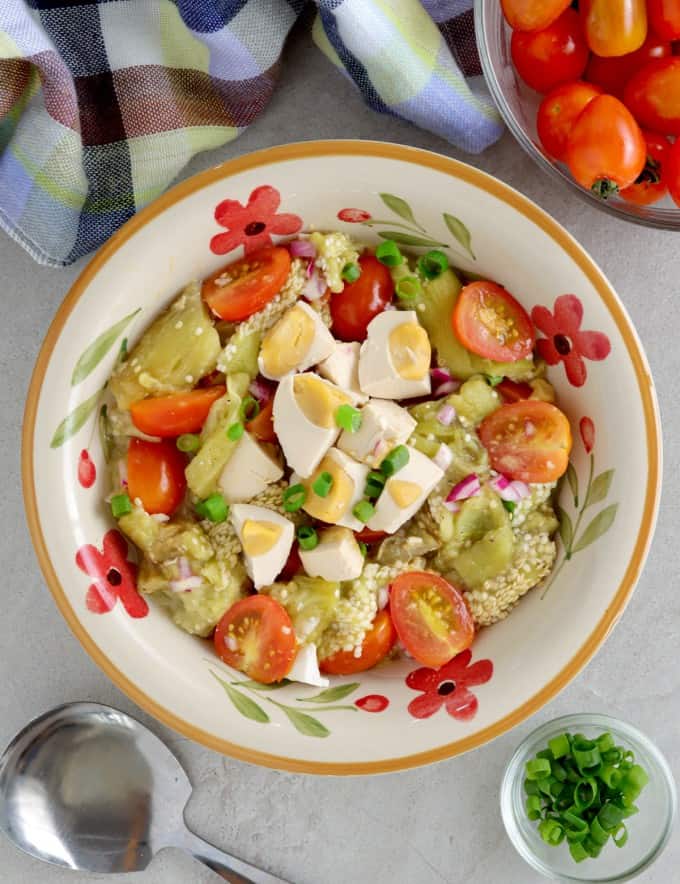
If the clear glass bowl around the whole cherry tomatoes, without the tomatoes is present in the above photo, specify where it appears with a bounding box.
[474,0,680,230]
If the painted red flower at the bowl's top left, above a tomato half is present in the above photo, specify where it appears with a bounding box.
[210,184,302,255]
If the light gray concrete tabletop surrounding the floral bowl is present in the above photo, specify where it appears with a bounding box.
[0,19,680,884]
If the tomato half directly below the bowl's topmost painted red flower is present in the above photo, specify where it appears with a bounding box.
[202,246,290,322]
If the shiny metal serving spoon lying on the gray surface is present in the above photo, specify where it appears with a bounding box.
[0,703,285,884]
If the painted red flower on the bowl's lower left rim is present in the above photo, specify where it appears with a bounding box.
[76,528,149,617]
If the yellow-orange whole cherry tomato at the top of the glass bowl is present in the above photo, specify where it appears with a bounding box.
[579,0,647,57]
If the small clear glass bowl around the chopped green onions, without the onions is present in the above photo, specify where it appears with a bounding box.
[501,712,677,884]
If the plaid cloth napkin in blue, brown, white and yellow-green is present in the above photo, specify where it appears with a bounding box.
[0,0,501,266]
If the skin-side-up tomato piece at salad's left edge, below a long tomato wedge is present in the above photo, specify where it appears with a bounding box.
[127,439,187,516]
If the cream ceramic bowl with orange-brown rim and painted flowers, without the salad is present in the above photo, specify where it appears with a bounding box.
[23,141,661,774]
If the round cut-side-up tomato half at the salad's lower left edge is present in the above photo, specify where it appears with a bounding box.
[214,595,297,684]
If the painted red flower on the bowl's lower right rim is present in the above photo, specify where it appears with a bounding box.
[406,648,493,721]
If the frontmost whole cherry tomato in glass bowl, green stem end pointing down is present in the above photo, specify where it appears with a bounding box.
[566,94,644,199]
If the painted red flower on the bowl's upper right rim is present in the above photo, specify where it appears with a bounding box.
[531,295,611,387]
